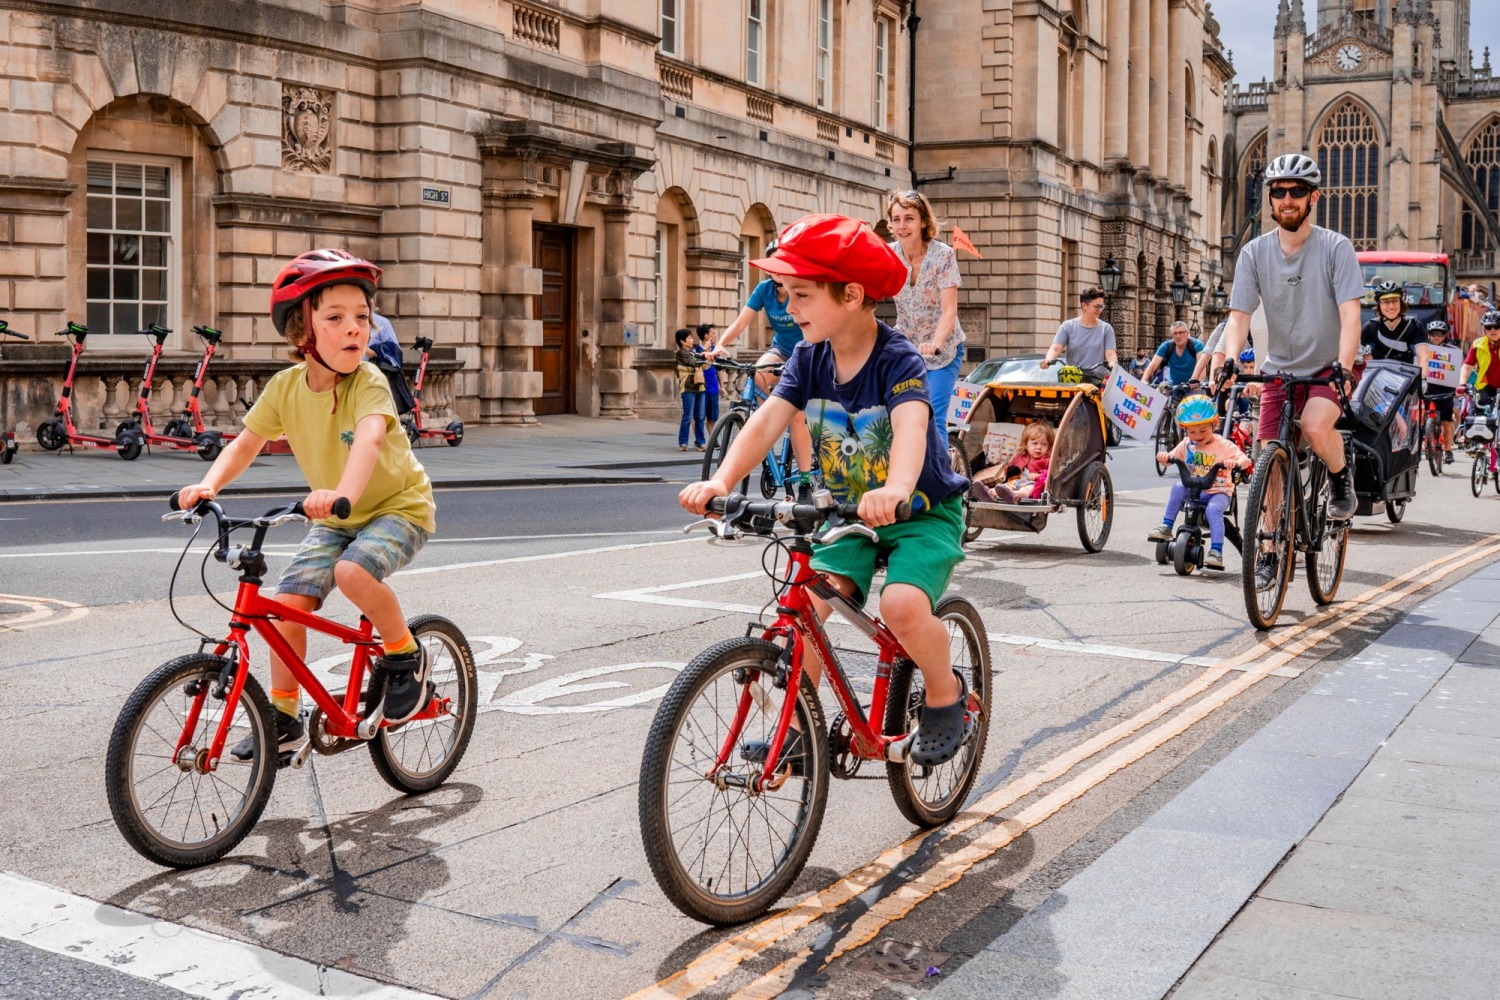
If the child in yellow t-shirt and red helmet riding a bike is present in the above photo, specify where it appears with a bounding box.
[180,250,437,760]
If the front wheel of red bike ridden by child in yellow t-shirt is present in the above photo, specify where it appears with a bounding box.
[104,654,279,868]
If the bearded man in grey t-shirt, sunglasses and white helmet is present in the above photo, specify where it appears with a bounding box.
[1214,153,1365,520]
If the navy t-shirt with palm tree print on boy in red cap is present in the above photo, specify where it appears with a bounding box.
[773,322,968,508]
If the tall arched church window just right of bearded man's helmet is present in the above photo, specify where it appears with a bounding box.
[1317,99,1380,250]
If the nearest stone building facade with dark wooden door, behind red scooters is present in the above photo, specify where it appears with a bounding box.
[0,0,909,433]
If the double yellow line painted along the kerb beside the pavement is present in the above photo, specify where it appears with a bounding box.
[627,534,1500,1000]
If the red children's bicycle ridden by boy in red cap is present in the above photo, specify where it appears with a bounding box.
[639,490,990,924]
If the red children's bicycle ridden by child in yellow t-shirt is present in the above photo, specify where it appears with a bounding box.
[105,495,477,868]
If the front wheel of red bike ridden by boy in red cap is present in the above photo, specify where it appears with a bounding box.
[638,637,830,925]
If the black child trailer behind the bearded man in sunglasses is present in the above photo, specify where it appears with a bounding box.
[1341,361,1422,525]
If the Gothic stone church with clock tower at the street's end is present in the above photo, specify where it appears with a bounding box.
[1224,0,1500,282]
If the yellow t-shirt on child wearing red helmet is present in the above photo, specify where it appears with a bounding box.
[245,361,438,531]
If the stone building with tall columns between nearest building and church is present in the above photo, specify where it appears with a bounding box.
[915,0,1233,354]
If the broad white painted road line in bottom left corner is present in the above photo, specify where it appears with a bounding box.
[0,871,437,1000]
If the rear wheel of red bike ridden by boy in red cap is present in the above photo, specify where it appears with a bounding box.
[885,594,993,828]
